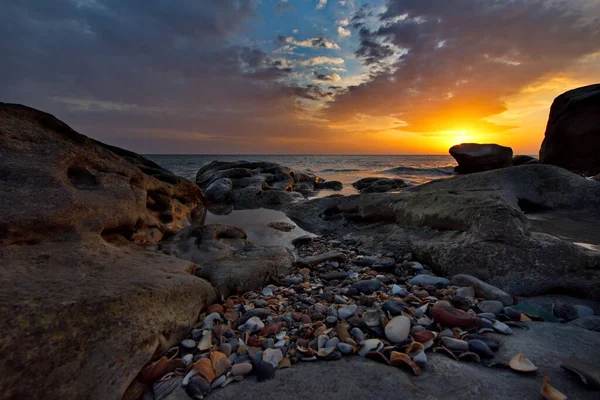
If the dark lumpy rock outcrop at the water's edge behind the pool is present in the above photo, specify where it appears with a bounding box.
[196,161,342,211]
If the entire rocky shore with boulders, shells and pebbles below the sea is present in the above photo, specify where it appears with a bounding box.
[0,86,600,400]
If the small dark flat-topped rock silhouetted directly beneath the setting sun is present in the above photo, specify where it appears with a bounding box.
[450,143,512,174]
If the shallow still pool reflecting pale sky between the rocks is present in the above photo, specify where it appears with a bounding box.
[205,208,314,248]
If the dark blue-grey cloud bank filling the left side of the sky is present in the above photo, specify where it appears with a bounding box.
[0,0,318,152]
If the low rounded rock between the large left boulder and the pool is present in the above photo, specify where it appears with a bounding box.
[161,224,294,297]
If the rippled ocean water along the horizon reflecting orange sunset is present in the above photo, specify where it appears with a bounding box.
[146,154,456,194]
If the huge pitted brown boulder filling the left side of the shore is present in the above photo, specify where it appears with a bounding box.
[0,103,217,399]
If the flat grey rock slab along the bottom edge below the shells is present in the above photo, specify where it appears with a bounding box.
[210,323,600,400]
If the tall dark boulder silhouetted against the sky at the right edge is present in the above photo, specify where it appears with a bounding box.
[540,84,600,176]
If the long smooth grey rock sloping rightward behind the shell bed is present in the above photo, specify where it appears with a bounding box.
[286,165,600,298]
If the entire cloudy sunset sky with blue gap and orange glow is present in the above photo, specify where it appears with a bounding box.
[0,0,600,154]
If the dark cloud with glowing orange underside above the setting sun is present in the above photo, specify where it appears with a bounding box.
[325,0,600,132]
